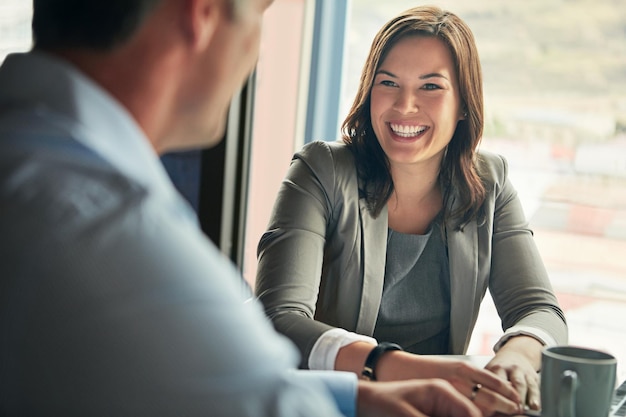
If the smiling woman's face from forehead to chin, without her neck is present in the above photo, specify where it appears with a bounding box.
[370,36,463,167]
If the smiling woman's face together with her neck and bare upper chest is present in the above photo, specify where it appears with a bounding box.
[370,36,458,234]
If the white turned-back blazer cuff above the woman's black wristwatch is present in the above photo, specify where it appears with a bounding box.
[309,328,378,371]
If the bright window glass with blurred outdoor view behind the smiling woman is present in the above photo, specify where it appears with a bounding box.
[342,0,626,379]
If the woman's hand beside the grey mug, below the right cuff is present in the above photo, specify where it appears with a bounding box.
[485,336,543,410]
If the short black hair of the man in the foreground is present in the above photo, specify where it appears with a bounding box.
[32,0,162,51]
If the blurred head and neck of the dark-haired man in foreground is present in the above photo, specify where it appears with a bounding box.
[33,0,272,153]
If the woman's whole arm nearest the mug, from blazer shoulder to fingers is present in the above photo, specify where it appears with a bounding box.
[478,152,567,408]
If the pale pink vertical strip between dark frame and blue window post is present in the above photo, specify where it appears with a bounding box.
[242,0,314,287]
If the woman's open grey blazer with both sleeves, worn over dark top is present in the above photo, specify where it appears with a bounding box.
[256,142,567,367]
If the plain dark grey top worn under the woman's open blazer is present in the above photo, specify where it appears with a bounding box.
[374,221,450,355]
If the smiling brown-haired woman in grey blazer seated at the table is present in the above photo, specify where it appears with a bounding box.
[256,7,567,409]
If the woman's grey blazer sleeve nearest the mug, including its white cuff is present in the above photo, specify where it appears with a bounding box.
[480,153,567,344]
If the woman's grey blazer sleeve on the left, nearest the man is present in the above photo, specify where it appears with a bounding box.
[255,142,342,368]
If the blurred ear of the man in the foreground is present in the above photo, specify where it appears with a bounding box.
[183,0,227,51]
